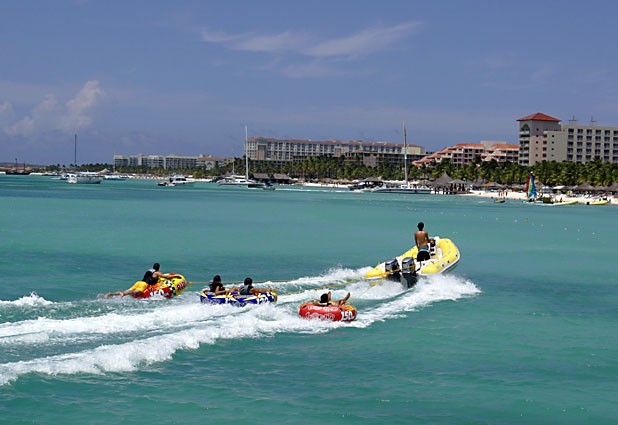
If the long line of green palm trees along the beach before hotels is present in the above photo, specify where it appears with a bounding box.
[41,156,618,186]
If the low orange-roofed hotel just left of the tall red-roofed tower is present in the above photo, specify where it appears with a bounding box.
[414,141,519,166]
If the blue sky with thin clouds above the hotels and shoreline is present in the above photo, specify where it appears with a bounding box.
[0,0,618,165]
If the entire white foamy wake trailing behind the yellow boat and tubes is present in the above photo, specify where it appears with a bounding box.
[0,268,480,385]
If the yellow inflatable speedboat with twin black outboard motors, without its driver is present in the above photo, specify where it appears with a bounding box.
[365,236,461,288]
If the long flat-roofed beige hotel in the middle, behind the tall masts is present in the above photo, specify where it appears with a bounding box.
[246,137,425,167]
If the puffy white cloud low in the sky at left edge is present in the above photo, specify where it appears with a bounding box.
[0,80,105,136]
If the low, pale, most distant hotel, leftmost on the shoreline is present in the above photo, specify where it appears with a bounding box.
[114,154,227,170]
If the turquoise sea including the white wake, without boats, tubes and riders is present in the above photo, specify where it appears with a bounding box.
[0,175,618,425]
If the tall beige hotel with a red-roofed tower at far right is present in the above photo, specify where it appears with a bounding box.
[517,112,618,166]
